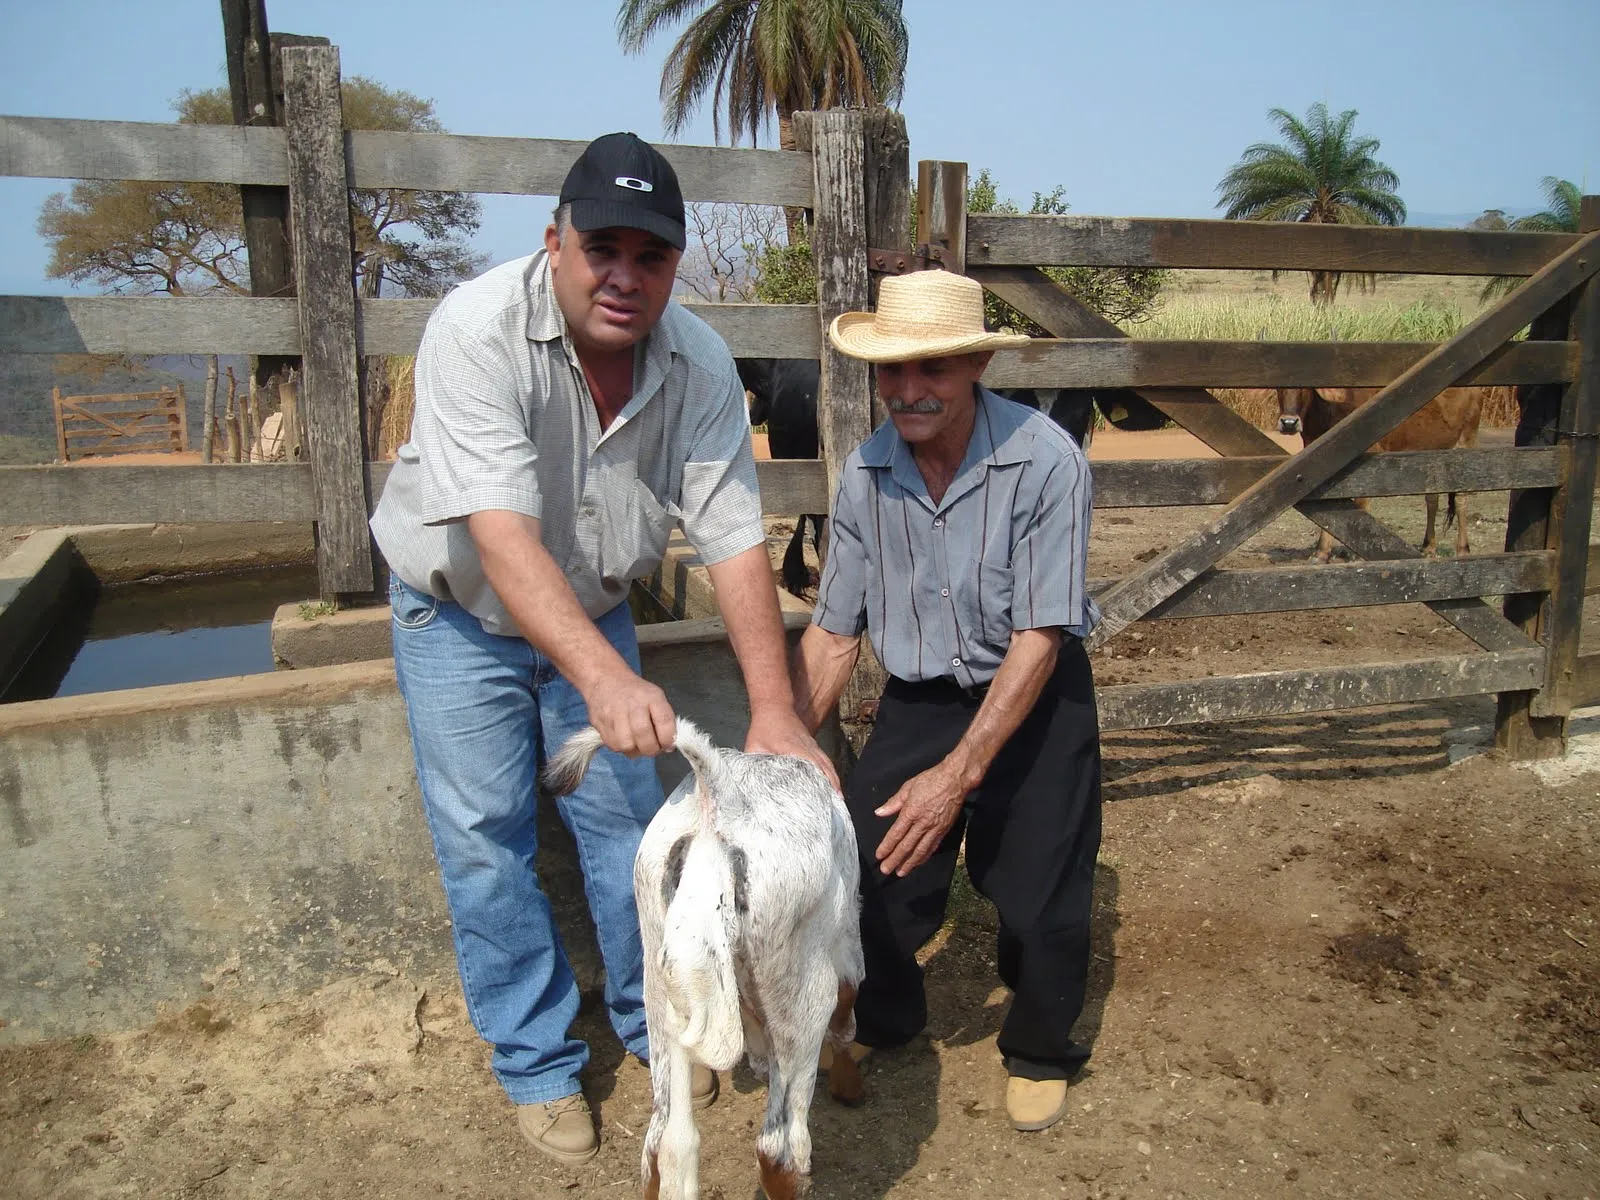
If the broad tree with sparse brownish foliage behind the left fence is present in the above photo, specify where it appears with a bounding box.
[38,75,485,296]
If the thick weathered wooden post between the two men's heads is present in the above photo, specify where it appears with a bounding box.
[795,109,883,723]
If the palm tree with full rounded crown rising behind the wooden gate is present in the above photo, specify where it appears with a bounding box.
[1216,101,1405,304]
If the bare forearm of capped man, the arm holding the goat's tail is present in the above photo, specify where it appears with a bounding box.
[467,512,632,694]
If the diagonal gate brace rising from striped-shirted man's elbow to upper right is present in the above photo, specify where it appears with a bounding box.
[1090,234,1600,648]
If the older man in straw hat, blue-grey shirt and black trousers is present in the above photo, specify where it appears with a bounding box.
[794,270,1101,1130]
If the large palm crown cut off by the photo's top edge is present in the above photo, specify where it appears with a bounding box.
[616,0,907,150]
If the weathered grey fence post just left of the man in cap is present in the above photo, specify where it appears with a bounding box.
[283,46,376,600]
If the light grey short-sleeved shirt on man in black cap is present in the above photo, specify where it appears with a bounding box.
[373,250,765,635]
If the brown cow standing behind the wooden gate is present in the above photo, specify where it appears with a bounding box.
[1277,387,1491,563]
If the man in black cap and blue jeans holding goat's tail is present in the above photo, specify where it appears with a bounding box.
[373,133,832,1162]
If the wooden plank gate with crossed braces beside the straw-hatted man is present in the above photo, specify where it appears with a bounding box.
[917,162,1600,757]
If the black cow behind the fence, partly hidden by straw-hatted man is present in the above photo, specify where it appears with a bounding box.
[736,358,1166,595]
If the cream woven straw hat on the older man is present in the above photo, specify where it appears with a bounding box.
[827,270,1029,363]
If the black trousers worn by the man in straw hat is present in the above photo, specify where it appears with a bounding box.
[845,637,1101,1080]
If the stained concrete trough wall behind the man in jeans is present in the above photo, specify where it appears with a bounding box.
[0,621,802,1042]
